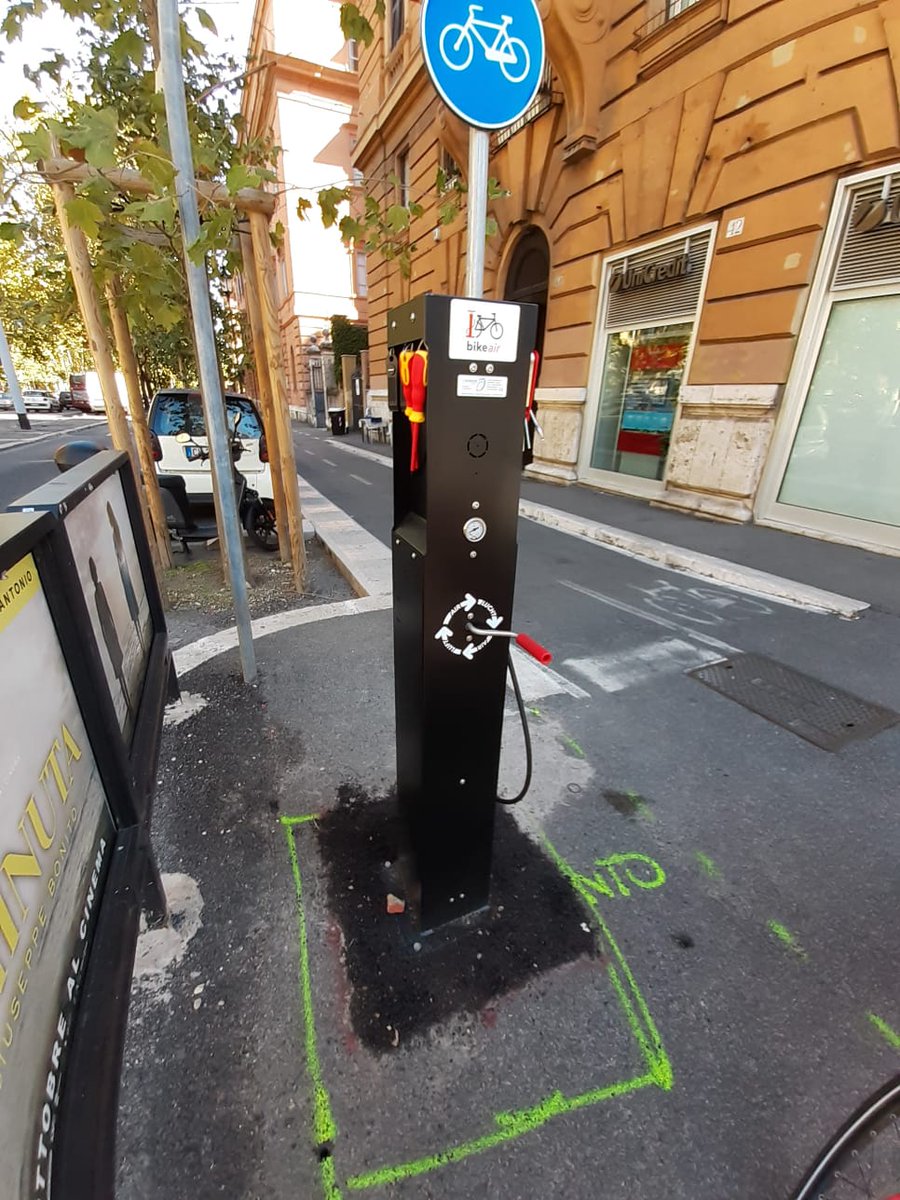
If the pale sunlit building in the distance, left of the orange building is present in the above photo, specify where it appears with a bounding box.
[241,0,366,425]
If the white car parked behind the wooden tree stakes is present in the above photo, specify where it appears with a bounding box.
[149,388,272,504]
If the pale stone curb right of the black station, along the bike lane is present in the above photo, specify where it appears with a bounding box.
[518,500,870,619]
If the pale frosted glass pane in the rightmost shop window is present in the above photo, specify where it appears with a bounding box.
[779,296,900,526]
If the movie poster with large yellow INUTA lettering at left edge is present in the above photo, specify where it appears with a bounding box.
[0,556,113,1200]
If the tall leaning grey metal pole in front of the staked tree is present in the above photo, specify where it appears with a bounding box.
[158,0,257,683]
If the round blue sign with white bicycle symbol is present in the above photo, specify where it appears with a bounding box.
[421,0,544,130]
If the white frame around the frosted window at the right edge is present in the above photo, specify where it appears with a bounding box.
[754,163,900,554]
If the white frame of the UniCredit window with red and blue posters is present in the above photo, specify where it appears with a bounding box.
[577,221,719,500]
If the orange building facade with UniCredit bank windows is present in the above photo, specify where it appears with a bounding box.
[354,0,900,553]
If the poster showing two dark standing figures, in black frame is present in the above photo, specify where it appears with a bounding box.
[66,475,152,742]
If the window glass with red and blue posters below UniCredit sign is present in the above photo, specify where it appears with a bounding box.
[590,322,694,480]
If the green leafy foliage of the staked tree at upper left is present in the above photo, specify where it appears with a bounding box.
[0,0,276,385]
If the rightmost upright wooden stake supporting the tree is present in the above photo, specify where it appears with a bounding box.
[250,211,306,592]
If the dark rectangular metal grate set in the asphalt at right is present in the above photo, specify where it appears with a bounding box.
[688,654,900,750]
